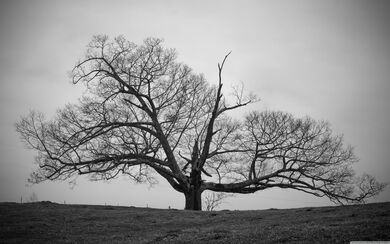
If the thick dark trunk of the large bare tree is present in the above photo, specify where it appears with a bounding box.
[184,170,202,210]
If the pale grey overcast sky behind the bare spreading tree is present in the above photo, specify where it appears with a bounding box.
[0,0,390,209]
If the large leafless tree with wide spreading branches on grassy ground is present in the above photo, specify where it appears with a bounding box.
[16,36,384,210]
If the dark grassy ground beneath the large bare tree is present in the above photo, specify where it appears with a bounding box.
[0,202,390,243]
